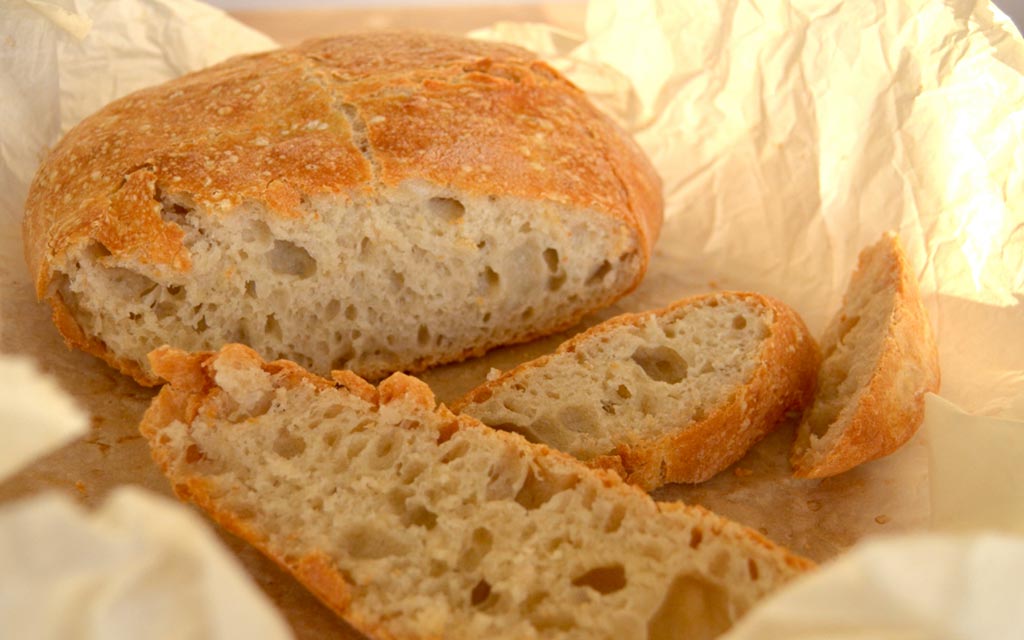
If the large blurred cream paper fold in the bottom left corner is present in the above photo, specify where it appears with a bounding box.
[0,486,292,640]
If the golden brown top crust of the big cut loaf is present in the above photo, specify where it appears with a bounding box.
[25,33,662,385]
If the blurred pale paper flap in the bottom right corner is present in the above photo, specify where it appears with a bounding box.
[724,534,1024,640]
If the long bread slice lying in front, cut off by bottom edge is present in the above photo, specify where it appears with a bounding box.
[141,345,811,640]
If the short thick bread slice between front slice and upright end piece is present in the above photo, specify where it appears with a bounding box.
[453,293,819,490]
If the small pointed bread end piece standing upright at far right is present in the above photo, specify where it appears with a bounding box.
[792,231,939,478]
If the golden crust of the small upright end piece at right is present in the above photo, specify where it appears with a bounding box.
[792,231,941,478]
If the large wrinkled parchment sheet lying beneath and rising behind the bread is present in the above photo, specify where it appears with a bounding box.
[0,0,1024,637]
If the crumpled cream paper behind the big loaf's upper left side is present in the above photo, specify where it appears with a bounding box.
[0,0,275,221]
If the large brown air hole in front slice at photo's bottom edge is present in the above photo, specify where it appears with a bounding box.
[647,574,732,640]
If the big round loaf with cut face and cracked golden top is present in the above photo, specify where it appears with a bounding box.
[25,34,662,384]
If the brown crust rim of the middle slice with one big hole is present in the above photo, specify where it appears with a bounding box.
[453,292,821,490]
